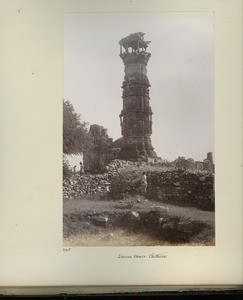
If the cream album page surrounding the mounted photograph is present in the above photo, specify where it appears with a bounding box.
[0,0,243,287]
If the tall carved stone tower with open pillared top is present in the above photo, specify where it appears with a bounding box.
[119,32,156,161]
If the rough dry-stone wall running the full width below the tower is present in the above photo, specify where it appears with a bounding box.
[63,160,215,210]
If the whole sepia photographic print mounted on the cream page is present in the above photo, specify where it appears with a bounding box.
[63,12,215,247]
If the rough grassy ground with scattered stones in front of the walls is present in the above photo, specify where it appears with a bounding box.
[63,196,214,246]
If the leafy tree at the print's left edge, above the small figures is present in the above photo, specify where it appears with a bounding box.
[63,100,90,154]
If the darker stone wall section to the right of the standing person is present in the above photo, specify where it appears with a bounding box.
[147,170,214,210]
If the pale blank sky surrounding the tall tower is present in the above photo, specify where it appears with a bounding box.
[64,12,214,160]
